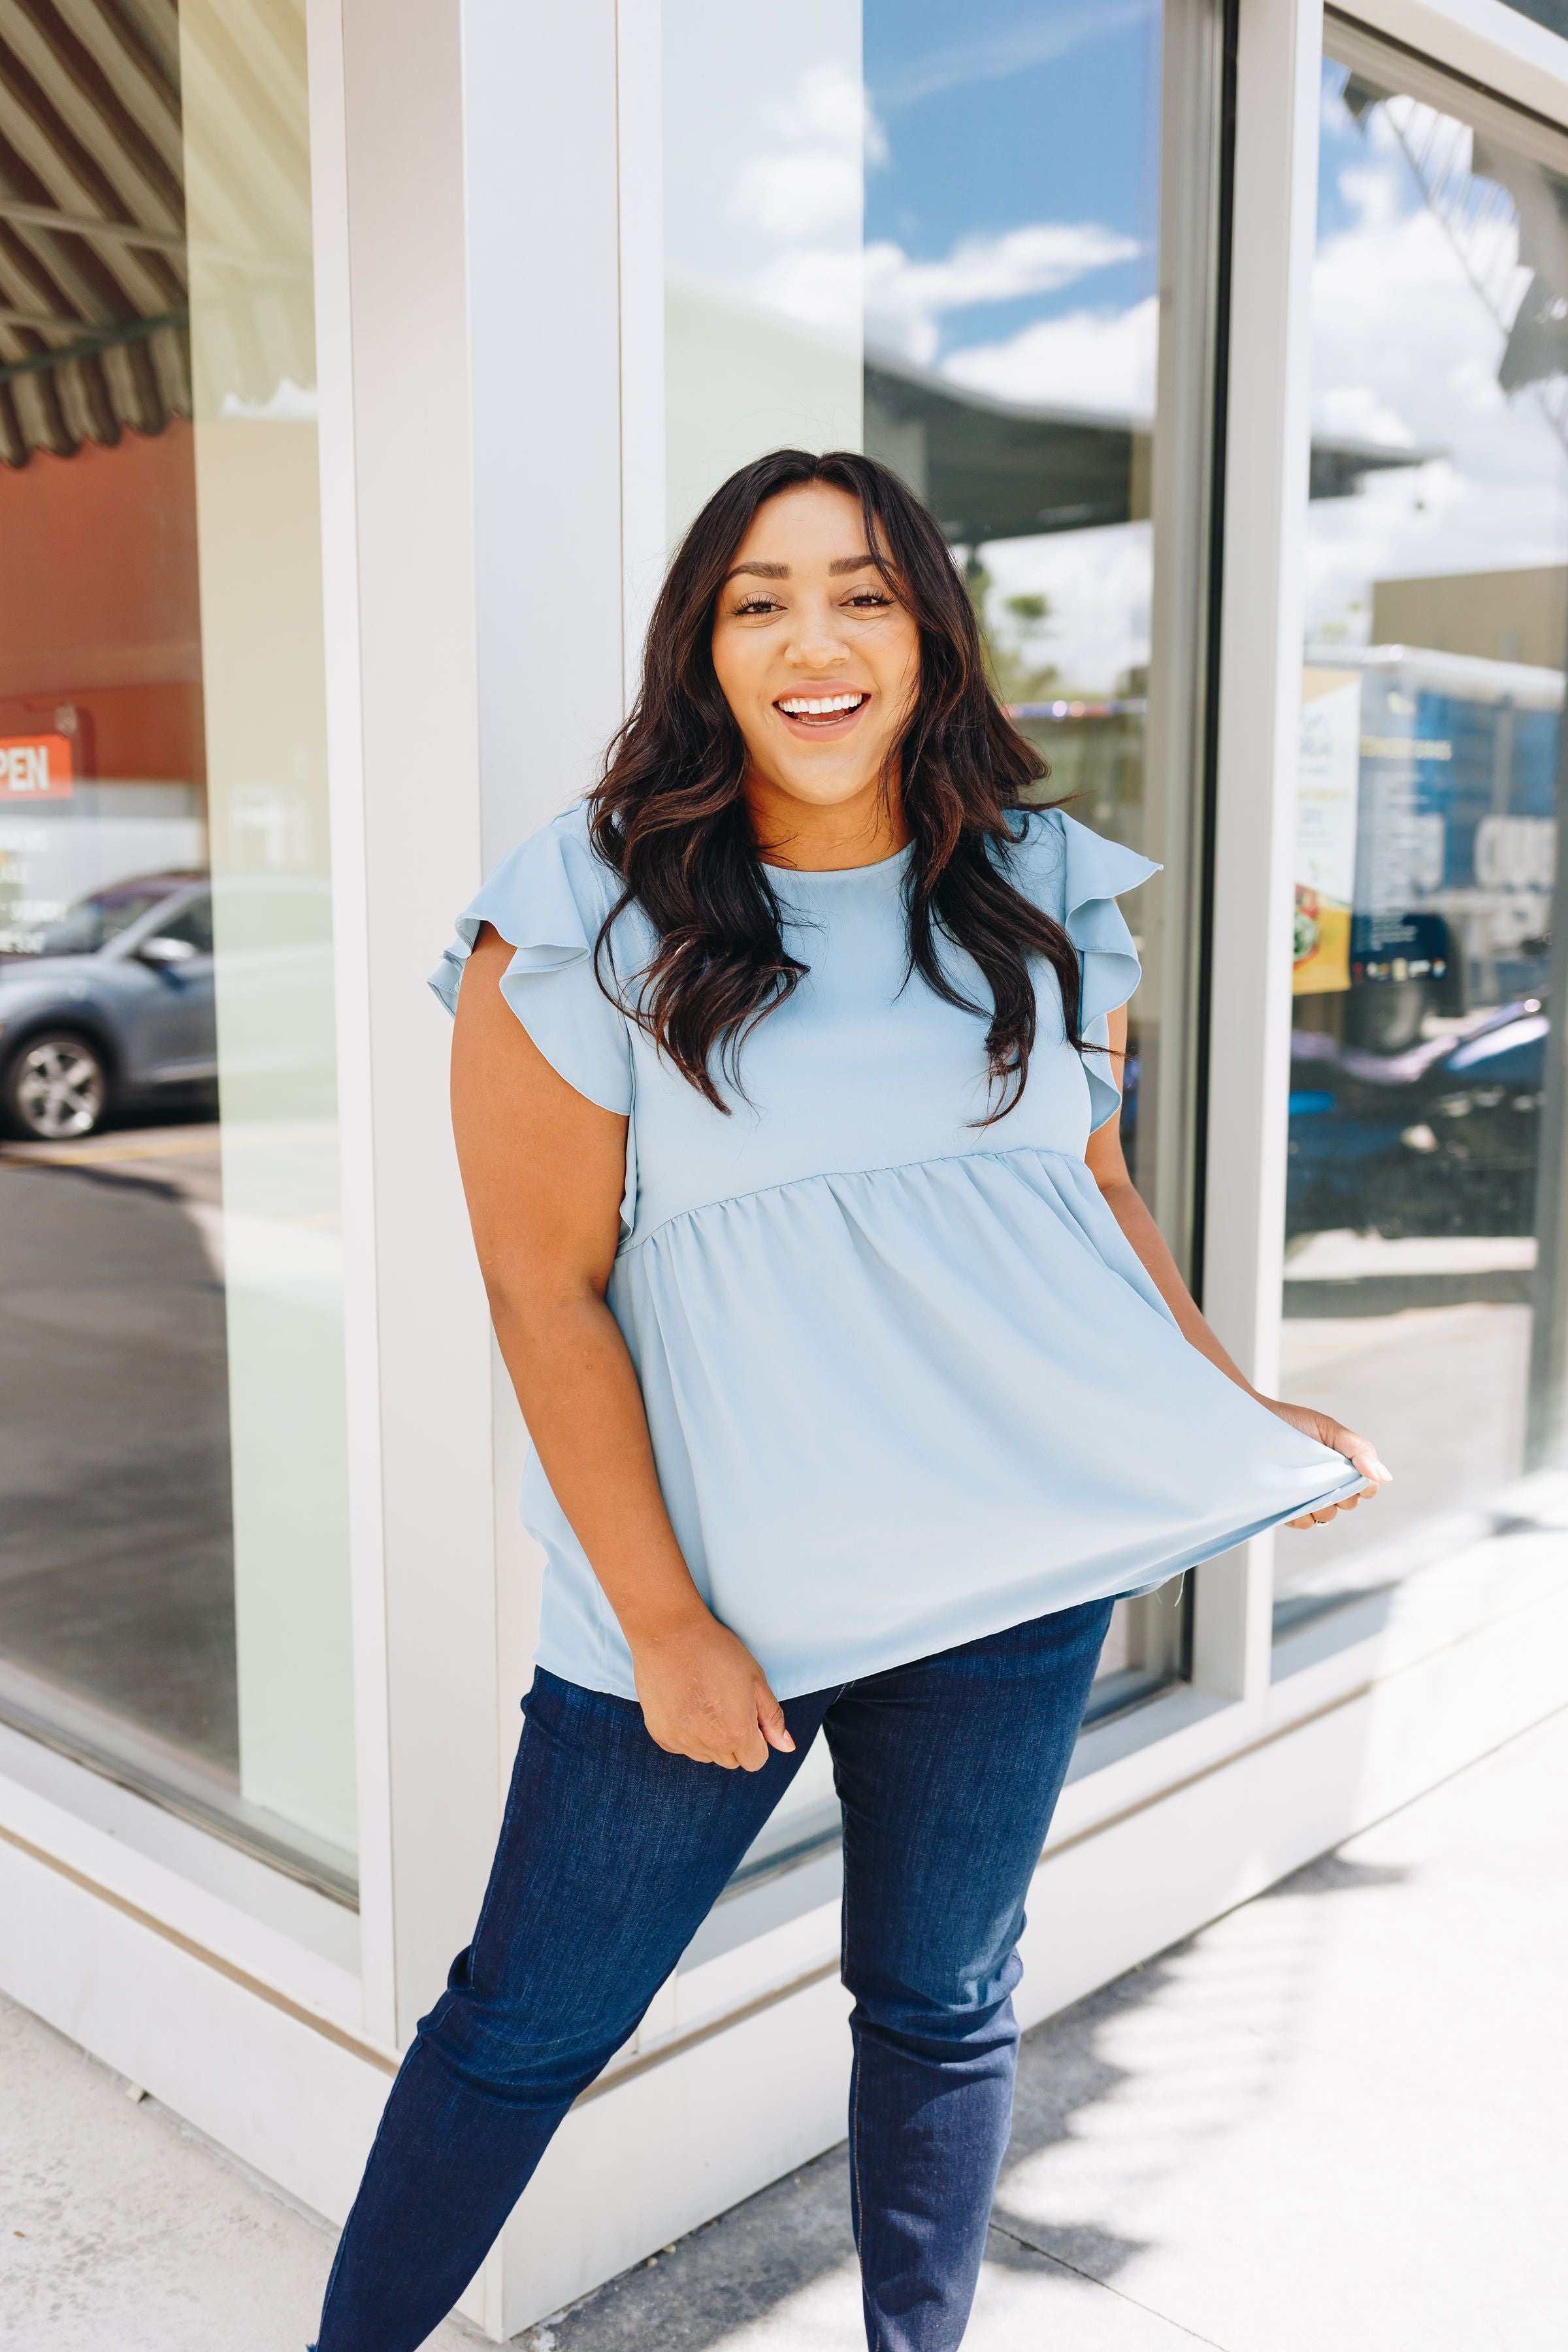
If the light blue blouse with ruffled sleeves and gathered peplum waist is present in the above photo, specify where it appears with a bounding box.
[430,807,1361,1698]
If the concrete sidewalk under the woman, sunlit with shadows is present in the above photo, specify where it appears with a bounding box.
[0,1714,1568,2352]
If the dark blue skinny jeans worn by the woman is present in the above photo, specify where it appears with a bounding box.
[319,1602,1112,2352]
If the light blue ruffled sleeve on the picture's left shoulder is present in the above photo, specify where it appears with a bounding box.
[430,809,632,1117]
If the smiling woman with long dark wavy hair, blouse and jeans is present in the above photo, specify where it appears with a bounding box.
[319,449,1387,2352]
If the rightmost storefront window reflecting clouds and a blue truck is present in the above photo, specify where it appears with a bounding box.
[1277,33,1568,1630]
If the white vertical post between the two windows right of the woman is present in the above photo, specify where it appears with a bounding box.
[1194,0,1324,1710]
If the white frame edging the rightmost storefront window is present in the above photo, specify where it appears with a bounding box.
[1206,0,1568,1731]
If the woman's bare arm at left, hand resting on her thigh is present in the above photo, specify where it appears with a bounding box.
[451,924,794,1771]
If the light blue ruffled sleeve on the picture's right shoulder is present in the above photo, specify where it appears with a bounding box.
[1015,809,1159,1132]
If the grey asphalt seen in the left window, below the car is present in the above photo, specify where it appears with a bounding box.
[0,1124,237,1773]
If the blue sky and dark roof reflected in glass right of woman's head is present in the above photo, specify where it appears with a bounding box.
[865,0,1164,1213]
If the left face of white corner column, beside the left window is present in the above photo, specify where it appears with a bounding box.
[322,0,498,2042]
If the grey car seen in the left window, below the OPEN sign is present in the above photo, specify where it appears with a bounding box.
[0,873,219,1143]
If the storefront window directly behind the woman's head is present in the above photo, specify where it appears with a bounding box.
[663,0,1211,1778]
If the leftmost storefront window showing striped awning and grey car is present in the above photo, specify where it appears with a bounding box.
[0,0,355,1898]
